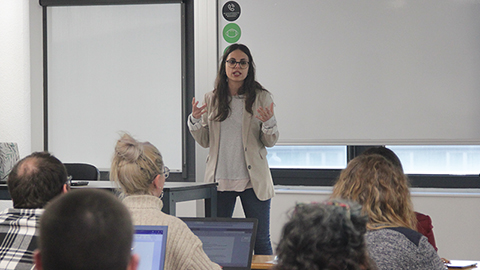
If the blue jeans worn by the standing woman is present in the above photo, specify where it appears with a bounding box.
[217,188,273,255]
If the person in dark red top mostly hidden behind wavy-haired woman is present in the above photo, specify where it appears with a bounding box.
[362,146,438,251]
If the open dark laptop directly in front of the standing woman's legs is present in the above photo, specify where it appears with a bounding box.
[181,218,257,270]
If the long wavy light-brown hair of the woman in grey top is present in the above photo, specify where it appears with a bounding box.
[332,154,417,230]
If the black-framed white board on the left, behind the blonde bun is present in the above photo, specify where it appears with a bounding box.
[47,4,183,171]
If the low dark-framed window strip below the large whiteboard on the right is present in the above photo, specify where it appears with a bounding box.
[267,145,480,188]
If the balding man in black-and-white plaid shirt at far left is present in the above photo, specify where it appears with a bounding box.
[0,152,69,270]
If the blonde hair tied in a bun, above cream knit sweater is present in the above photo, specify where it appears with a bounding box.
[110,133,163,195]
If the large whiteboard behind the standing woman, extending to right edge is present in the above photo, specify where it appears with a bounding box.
[218,0,480,145]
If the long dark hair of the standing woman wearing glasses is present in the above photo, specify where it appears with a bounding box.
[213,43,267,122]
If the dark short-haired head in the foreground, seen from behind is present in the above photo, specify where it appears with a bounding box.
[35,189,138,270]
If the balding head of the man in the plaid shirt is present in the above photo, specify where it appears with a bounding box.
[7,152,68,208]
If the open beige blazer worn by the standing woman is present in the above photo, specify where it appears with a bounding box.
[190,90,279,201]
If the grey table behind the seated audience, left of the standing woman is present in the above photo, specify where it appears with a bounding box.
[0,181,217,217]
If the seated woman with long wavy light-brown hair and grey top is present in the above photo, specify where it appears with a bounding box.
[332,155,445,270]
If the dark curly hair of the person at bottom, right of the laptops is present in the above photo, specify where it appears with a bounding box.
[275,200,375,270]
